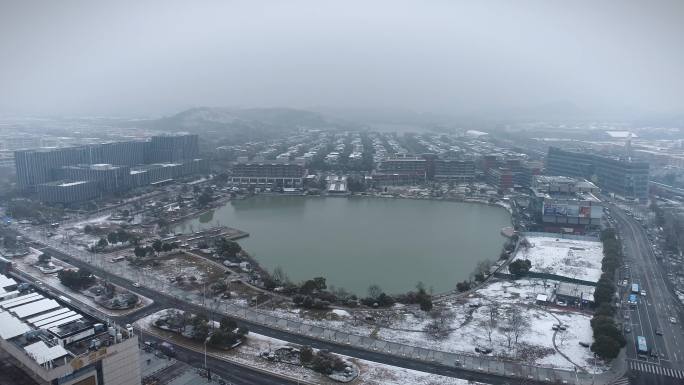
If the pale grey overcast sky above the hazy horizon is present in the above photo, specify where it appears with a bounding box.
[0,0,684,115]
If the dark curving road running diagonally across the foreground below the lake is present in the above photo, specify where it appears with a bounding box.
[5,229,542,385]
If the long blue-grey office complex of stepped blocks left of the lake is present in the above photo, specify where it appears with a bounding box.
[14,135,203,203]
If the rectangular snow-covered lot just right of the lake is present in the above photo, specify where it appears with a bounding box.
[515,236,603,282]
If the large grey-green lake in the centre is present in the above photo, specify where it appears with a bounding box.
[176,196,511,296]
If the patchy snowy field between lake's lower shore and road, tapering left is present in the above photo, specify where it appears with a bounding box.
[262,279,608,373]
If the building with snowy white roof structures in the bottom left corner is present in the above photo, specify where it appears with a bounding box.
[0,272,141,385]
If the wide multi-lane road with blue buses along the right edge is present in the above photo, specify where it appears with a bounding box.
[611,206,684,384]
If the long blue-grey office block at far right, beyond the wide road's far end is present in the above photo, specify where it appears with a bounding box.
[546,147,649,202]
